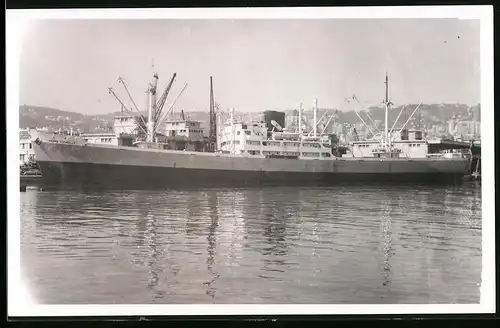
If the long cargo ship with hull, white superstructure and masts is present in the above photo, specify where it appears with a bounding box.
[31,74,471,189]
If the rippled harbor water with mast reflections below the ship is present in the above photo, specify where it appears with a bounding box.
[20,182,482,304]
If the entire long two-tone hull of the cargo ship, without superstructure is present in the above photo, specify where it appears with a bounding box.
[34,143,469,189]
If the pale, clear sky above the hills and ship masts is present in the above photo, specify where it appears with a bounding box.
[19,18,480,114]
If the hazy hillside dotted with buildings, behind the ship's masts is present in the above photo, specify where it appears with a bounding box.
[19,104,480,133]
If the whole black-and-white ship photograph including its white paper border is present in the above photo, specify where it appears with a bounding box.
[7,6,495,316]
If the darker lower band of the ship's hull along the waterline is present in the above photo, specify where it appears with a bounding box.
[40,162,463,189]
